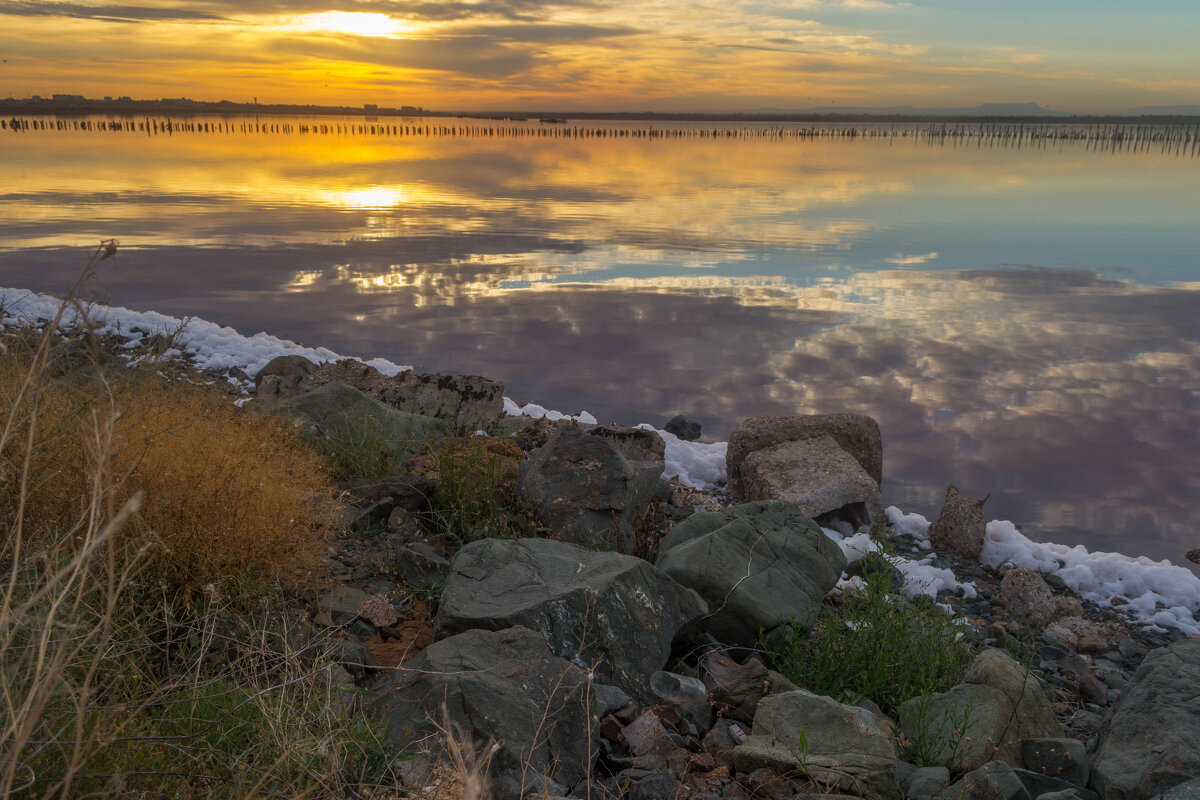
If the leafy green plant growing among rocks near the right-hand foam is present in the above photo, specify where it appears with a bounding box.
[772,559,972,715]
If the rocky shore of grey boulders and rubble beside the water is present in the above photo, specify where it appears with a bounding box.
[256,356,1200,800]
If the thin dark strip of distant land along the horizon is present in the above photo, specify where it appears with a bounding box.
[7,97,1200,125]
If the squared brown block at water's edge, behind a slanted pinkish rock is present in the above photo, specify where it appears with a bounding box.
[725,414,883,498]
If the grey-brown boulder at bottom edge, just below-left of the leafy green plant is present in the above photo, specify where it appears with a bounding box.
[733,688,901,800]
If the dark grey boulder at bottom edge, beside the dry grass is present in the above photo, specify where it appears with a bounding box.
[367,627,599,800]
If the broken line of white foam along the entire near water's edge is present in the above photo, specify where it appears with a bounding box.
[11,288,1200,634]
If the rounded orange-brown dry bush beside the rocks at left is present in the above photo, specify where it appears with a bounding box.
[116,373,331,591]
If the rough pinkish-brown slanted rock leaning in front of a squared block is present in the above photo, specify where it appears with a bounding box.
[742,435,887,524]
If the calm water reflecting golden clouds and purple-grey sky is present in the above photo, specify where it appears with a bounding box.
[7,119,1200,564]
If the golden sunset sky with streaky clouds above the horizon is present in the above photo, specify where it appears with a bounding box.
[0,0,1200,113]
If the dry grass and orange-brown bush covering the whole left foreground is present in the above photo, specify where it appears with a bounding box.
[0,284,395,799]
